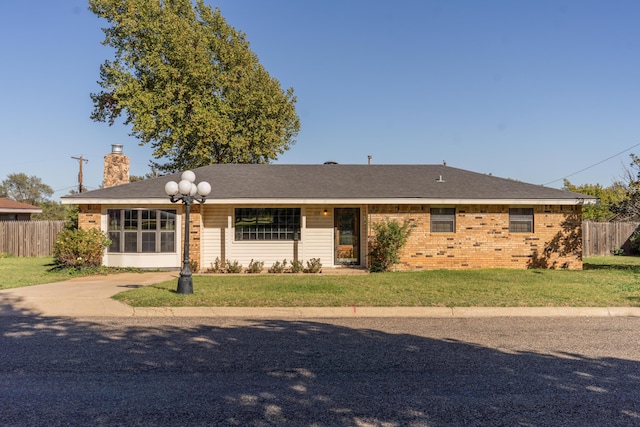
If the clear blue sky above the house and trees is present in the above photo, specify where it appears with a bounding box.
[0,0,640,200]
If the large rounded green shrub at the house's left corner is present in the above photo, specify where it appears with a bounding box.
[53,229,111,268]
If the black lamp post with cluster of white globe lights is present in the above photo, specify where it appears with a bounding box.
[164,171,211,294]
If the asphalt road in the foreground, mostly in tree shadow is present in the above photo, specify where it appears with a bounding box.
[0,316,640,427]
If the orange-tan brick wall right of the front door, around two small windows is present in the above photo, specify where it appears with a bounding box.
[368,205,582,270]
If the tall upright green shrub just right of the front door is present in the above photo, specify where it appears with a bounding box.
[369,220,413,272]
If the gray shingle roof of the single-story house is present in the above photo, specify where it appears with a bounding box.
[63,164,597,203]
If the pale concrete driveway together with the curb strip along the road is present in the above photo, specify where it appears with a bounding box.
[0,271,640,319]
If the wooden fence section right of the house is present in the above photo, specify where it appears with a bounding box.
[582,221,640,257]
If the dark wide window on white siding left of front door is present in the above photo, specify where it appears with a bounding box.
[235,208,300,240]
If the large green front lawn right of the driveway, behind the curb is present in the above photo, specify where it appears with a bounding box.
[115,257,640,307]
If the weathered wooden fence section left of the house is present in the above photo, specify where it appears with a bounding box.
[0,221,65,257]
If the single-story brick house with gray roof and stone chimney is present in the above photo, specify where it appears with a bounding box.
[62,145,598,271]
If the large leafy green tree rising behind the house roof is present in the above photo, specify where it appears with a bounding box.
[89,0,300,173]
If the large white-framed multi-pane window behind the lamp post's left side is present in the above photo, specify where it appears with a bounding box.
[107,209,176,253]
